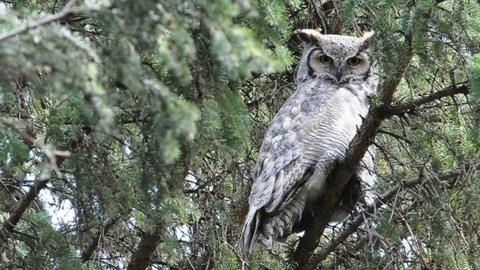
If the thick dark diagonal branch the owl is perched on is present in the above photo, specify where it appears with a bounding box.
[293,34,413,269]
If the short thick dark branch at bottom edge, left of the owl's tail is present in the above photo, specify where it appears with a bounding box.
[128,225,163,270]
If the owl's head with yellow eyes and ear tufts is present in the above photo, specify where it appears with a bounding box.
[295,29,373,84]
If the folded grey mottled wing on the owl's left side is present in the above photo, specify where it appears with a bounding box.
[240,96,314,252]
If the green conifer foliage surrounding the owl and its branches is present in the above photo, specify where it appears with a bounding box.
[0,0,480,269]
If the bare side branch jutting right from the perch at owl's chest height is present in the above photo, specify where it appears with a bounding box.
[383,81,470,117]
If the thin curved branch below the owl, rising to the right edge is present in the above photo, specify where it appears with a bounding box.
[309,163,480,269]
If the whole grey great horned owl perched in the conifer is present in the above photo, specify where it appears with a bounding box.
[240,29,377,252]
